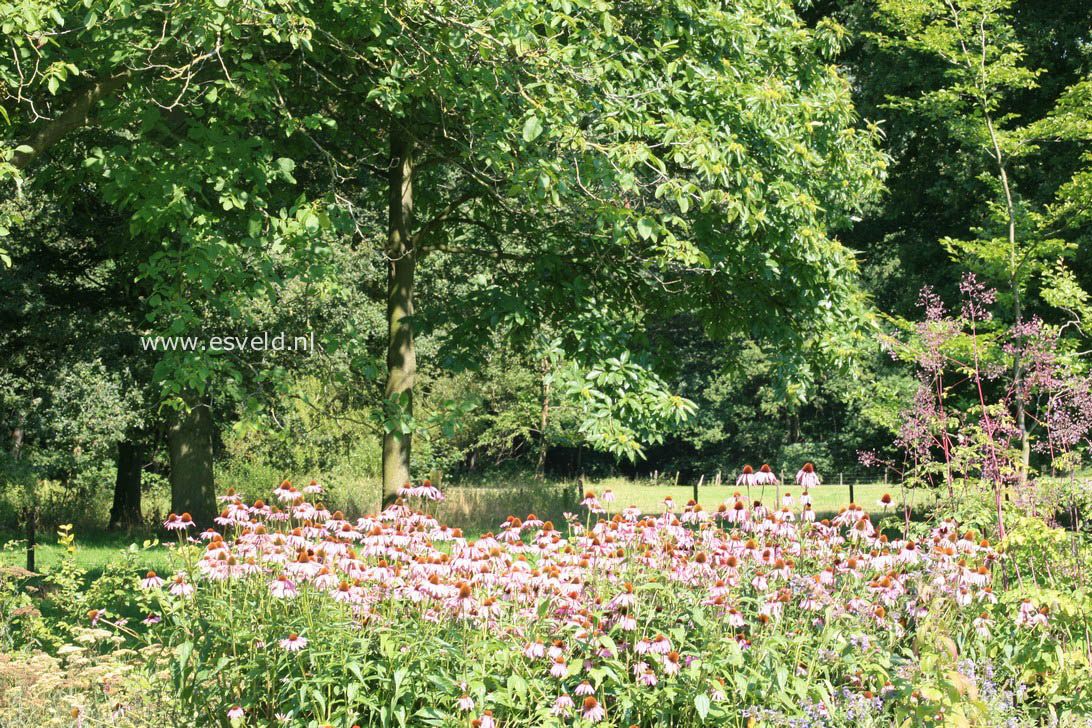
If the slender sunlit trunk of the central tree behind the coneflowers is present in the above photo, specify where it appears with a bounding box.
[383,122,417,504]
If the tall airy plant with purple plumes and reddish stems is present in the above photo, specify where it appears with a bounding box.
[860,273,1092,538]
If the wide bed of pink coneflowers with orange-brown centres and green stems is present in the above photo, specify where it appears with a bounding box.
[70,475,1092,728]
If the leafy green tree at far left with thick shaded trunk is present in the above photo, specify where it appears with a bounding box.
[0,0,338,522]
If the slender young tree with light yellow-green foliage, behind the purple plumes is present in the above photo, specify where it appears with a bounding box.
[869,0,1092,479]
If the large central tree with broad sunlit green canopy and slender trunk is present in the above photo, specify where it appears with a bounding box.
[288,0,883,497]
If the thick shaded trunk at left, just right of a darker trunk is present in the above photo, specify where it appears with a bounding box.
[167,396,216,527]
